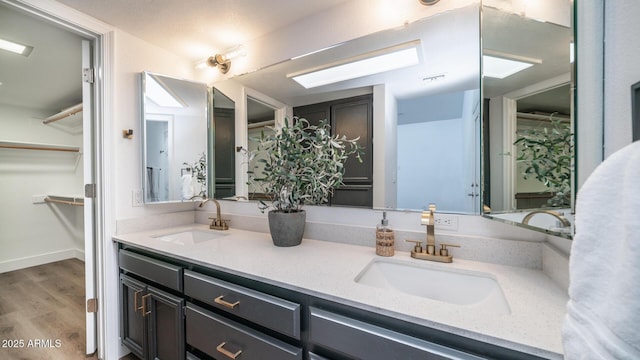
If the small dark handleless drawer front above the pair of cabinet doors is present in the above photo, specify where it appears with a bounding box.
[118,250,183,291]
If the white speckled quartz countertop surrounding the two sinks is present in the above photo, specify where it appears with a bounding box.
[114,224,568,359]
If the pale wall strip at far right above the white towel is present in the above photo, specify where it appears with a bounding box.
[604,0,640,157]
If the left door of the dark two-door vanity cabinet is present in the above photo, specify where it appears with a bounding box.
[120,274,147,359]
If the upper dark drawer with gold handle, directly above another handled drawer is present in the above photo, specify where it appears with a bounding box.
[184,270,300,339]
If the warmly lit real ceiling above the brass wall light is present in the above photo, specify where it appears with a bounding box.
[57,0,347,61]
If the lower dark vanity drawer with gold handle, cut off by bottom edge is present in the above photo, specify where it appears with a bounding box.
[185,303,302,360]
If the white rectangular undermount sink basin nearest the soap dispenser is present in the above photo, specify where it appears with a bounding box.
[354,259,511,314]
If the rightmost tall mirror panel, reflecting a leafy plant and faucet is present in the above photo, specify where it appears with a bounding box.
[482,1,575,237]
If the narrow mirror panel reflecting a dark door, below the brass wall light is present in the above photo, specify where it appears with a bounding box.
[209,88,236,199]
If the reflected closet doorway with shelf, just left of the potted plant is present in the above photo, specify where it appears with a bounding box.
[247,96,276,200]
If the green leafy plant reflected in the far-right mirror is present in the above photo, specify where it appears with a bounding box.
[514,114,574,206]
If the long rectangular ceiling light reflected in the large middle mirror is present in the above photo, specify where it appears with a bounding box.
[287,40,420,89]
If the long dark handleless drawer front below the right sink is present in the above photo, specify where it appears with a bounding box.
[309,307,483,360]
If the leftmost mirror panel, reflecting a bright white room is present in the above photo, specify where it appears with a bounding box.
[141,72,207,204]
